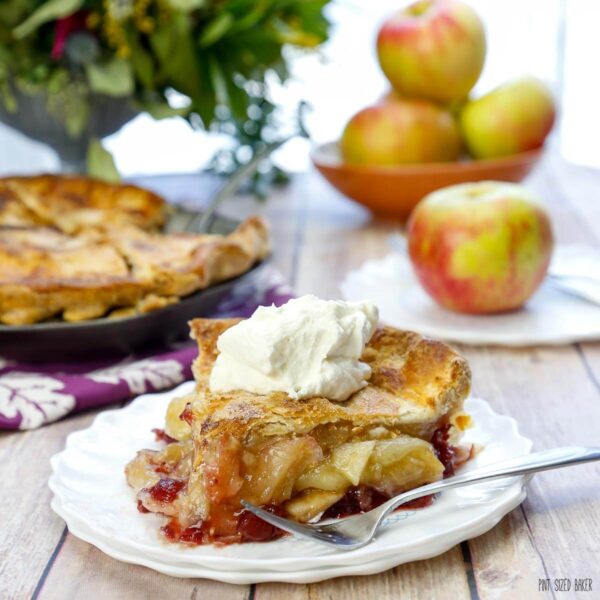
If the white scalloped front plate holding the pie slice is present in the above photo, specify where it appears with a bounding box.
[49,382,532,583]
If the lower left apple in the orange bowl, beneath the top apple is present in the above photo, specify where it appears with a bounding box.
[340,96,462,165]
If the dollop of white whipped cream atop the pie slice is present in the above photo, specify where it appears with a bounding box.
[209,296,379,401]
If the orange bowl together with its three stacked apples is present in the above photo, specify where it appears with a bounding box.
[311,0,556,221]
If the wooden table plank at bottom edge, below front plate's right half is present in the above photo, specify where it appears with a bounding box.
[254,546,470,600]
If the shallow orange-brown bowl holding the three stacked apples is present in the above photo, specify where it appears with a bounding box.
[311,142,542,221]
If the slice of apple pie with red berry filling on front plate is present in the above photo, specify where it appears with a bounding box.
[125,319,470,544]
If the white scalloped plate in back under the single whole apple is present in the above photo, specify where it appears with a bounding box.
[340,253,600,346]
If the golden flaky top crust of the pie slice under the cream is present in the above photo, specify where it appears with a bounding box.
[190,319,471,439]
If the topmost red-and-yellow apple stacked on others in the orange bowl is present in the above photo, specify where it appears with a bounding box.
[377,0,486,103]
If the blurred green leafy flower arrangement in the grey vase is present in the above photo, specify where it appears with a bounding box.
[0,0,329,183]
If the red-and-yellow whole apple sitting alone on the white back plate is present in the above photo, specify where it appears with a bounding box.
[408,181,553,314]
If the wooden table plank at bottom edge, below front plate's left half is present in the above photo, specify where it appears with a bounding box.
[38,534,250,600]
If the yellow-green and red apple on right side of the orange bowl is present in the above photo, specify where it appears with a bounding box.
[460,77,556,158]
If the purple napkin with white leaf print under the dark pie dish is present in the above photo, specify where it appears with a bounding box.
[0,267,292,429]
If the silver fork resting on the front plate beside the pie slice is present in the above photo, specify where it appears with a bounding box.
[242,446,600,550]
